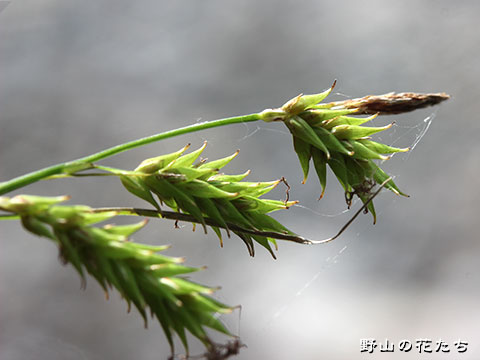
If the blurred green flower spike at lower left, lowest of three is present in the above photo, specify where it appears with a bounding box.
[0,195,233,354]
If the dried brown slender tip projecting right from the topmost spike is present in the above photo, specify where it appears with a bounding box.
[332,92,450,115]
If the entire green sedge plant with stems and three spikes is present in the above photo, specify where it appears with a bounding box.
[0,83,448,359]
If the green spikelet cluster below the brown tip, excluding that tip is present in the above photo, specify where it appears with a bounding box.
[280,89,409,219]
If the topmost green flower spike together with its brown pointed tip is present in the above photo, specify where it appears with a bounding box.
[262,82,448,223]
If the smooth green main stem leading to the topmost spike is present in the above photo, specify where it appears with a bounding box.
[0,113,262,195]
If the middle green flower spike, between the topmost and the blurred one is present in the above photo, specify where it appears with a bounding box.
[108,143,297,258]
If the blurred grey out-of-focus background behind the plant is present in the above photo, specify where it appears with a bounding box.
[0,0,480,360]
